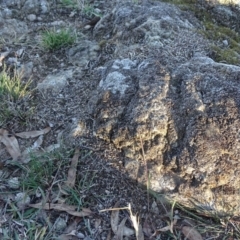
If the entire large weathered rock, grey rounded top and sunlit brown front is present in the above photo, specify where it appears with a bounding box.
[89,0,240,214]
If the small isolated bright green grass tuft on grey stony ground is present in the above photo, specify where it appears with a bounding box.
[42,29,76,51]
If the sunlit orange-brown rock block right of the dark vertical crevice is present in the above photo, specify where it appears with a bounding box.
[164,56,240,215]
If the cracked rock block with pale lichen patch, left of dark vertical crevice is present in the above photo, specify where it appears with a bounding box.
[90,59,170,164]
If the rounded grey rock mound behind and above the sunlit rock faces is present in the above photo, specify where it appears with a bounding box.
[93,2,208,67]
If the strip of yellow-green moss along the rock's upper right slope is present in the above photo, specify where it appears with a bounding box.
[158,0,240,65]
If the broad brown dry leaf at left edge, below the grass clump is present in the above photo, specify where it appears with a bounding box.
[0,129,21,160]
